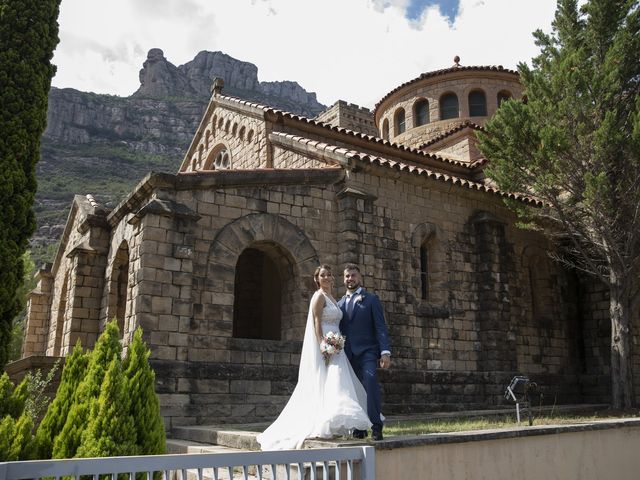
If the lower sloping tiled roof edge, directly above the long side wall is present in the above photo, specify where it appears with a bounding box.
[272,132,543,206]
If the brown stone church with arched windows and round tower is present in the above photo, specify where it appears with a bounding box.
[20,58,638,428]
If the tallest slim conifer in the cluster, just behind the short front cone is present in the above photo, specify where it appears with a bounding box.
[52,321,122,458]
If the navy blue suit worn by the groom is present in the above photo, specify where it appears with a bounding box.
[338,287,391,428]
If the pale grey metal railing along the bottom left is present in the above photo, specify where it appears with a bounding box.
[0,446,375,480]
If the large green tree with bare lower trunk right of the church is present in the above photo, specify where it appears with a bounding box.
[479,0,640,408]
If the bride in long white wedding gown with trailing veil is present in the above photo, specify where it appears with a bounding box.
[257,265,371,450]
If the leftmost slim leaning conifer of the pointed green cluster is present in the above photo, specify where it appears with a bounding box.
[36,340,89,459]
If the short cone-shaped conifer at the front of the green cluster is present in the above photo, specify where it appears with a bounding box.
[77,358,138,457]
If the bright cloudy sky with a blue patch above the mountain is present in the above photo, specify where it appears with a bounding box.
[52,0,556,108]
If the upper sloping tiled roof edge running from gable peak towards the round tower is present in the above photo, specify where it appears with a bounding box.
[217,94,476,169]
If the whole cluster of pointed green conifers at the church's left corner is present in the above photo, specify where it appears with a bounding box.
[36,321,165,458]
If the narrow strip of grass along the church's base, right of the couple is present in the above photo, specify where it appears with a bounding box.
[384,410,640,437]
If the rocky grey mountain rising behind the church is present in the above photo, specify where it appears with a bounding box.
[32,48,325,255]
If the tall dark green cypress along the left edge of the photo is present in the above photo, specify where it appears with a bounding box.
[0,0,60,367]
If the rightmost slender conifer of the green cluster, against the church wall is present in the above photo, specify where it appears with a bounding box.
[124,328,165,455]
